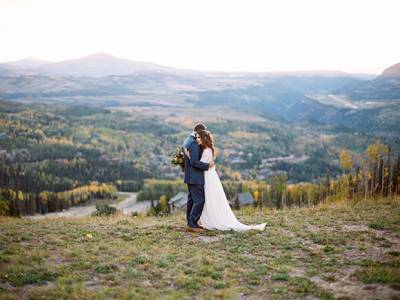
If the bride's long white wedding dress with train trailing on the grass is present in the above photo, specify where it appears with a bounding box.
[200,148,266,231]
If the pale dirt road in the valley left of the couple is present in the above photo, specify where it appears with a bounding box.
[27,192,150,219]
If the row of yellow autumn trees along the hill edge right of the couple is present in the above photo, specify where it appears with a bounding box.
[228,142,400,208]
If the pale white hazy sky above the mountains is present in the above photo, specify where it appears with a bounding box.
[0,0,400,73]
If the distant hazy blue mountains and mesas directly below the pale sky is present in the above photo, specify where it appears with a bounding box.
[0,53,400,134]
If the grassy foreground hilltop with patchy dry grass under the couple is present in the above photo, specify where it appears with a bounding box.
[0,199,400,299]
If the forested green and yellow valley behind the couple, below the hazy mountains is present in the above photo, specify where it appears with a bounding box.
[0,101,399,215]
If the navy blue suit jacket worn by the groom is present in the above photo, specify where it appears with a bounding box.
[182,134,209,185]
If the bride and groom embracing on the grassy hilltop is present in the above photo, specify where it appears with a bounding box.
[182,123,266,232]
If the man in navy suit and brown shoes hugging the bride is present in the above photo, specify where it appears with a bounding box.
[182,123,214,232]
